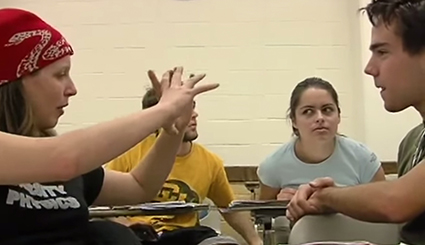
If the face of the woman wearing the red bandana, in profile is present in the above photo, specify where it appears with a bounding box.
[22,56,77,129]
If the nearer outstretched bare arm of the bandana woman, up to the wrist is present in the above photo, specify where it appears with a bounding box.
[0,105,173,185]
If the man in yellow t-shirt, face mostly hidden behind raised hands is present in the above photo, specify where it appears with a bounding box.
[106,89,262,245]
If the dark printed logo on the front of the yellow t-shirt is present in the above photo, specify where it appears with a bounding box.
[155,179,199,203]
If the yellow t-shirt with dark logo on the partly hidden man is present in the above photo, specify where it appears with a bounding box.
[106,135,234,232]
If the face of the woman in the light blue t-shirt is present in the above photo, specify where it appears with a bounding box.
[292,88,340,140]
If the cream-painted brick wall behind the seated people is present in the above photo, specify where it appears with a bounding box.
[3,0,420,165]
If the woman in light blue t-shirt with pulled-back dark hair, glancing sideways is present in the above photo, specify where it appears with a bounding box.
[258,77,385,201]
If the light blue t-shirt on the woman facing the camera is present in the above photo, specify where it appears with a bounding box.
[257,136,381,188]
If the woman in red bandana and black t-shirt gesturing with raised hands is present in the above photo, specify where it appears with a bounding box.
[0,8,218,245]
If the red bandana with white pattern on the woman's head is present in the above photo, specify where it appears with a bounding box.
[0,8,74,85]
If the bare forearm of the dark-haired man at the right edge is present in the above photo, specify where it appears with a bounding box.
[310,161,425,223]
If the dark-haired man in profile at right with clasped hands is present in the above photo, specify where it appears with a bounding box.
[287,0,425,245]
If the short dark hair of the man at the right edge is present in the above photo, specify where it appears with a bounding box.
[360,0,425,55]
